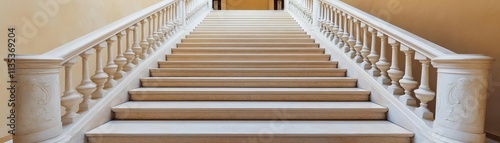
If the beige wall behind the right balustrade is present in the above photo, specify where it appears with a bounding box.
[342,0,500,135]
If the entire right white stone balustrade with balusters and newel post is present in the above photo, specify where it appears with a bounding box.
[287,0,493,142]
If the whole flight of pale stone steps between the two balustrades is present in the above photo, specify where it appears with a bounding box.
[86,11,413,143]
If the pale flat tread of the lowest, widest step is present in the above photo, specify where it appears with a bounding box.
[86,120,414,137]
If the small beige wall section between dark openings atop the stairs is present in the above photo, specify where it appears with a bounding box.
[221,0,274,10]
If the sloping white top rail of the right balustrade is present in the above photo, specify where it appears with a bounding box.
[322,0,456,59]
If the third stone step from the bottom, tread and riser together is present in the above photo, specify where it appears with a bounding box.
[129,88,370,101]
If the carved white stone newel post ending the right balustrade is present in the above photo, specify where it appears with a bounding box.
[432,54,493,143]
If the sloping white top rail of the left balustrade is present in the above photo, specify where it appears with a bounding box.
[41,0,178,63]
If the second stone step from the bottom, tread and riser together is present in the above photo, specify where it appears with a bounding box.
[112,101,387,120]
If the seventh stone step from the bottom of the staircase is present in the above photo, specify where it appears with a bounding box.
[166,54,330,61]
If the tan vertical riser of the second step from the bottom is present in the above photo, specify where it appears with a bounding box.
[113,108,386,120]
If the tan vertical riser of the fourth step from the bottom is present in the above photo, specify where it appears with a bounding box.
[141,79,356,88]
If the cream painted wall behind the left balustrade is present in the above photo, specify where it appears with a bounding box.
[0,0,161,138]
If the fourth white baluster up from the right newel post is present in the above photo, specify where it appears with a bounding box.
[376,33,391,85]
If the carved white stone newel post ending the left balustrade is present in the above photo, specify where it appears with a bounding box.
[9,56,62,143]
